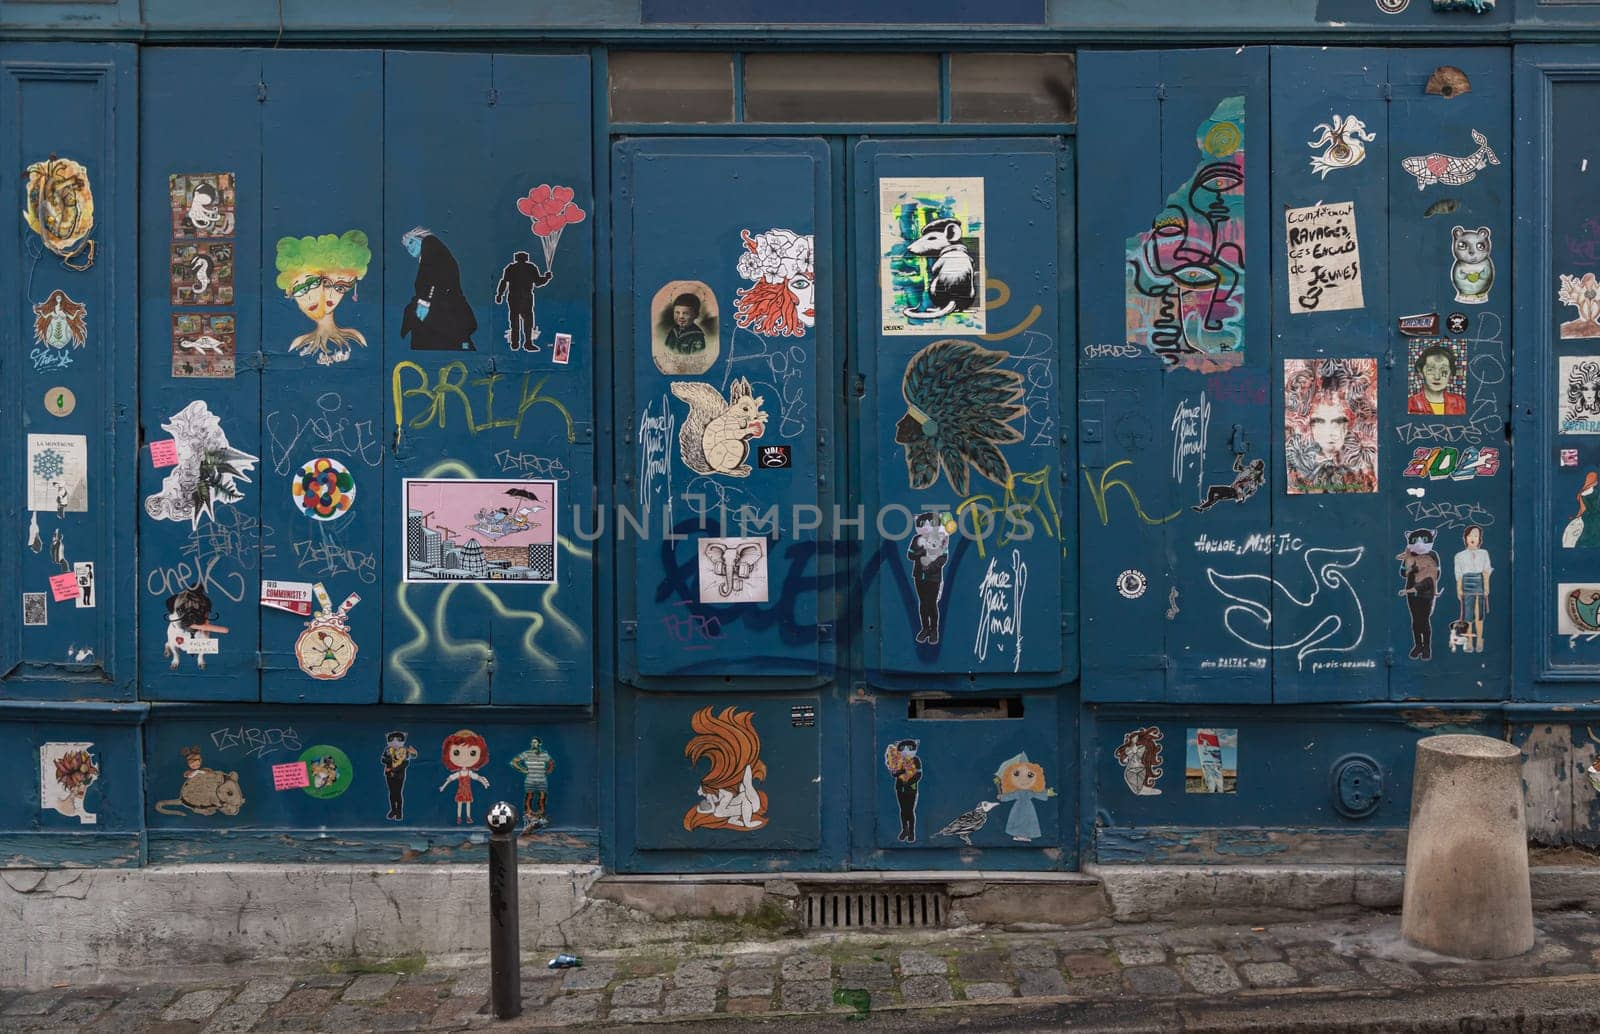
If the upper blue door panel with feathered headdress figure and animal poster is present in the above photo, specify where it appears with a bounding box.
[853,139,1077,688]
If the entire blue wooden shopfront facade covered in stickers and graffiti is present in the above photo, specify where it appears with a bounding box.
[0,0,1600,872]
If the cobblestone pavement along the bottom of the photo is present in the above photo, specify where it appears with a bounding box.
[9,912,1600,1034]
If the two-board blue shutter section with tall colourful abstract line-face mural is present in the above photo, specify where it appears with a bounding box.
[1078,48,1280,713]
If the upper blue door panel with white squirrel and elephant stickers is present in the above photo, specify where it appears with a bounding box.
[614,139,837,688]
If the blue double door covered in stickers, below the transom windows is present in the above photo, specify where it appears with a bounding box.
[613,138,1077,871]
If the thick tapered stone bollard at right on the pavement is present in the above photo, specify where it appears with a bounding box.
[1400,736,1533,959]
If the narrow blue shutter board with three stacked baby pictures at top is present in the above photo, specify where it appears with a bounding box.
[139,48,265,699]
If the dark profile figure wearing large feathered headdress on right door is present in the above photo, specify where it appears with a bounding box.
[894,339,1024,496]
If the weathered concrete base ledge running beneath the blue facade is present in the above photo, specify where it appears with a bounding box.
[9,864,1600,988]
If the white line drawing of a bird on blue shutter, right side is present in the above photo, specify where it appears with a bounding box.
[1205,546,1366,667]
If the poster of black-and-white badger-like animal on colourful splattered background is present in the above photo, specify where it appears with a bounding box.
[878,176,986,336]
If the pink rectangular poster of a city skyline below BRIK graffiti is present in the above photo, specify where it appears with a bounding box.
[405,479,557,584]
